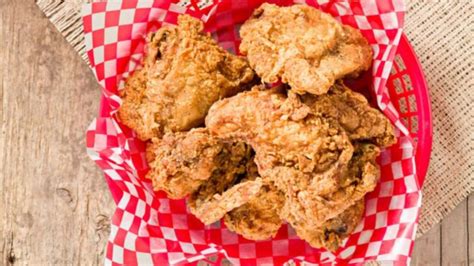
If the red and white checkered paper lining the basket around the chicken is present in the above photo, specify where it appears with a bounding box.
[83,0,421,265]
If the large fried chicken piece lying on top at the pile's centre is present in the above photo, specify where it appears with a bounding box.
[206,87,353,195]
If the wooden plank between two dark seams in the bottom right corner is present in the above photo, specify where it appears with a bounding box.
[441,200,468,265]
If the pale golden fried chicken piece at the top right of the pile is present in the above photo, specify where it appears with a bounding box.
[240,3,373,95]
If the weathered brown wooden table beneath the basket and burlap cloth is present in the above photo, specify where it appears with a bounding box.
[0,0,474,265]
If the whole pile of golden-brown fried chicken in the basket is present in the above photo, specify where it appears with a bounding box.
[123,6,396,251]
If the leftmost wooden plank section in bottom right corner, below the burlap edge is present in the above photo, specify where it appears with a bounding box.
[411,224,441,266]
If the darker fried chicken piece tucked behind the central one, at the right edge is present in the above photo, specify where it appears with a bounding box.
[303,81,397,147]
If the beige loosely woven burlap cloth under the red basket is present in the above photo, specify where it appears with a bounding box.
[37,0,474,236]
